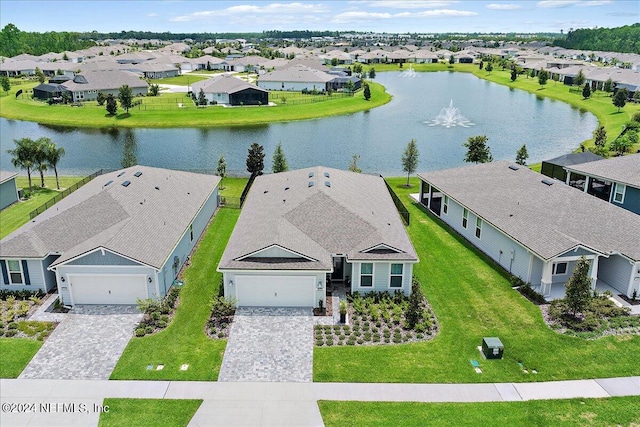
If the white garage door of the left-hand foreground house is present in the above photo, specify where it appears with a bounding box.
[69,274,147,304]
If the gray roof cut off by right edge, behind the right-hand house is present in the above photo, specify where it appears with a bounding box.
[565,154,640,188]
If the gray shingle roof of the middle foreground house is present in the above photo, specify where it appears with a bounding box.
[219,167,418,270]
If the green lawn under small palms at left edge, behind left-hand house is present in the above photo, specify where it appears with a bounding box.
[0,174,82,239]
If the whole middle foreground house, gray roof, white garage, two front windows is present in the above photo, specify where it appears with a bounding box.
[218,166,418,307]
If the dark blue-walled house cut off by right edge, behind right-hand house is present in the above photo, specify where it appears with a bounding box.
[565,154,640,215]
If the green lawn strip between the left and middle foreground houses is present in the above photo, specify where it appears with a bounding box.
[111,209,240,381]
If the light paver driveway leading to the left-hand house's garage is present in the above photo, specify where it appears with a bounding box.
[19,305,142,379]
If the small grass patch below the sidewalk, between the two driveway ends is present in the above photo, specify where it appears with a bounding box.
[98,398,202,427]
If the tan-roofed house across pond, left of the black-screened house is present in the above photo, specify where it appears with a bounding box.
[62,70,149,102]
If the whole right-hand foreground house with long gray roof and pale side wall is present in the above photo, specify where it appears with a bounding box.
[418,161,640,298]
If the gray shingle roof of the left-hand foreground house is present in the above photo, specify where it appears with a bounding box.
[0,166,220,268]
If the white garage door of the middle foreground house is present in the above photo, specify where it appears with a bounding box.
[235,276,315,307]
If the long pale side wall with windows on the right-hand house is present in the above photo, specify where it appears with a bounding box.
[440,198,534,285]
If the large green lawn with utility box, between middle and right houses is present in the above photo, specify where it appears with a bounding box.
[313,178,640,383]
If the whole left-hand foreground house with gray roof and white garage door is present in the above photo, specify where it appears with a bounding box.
[0,166,220,305]
